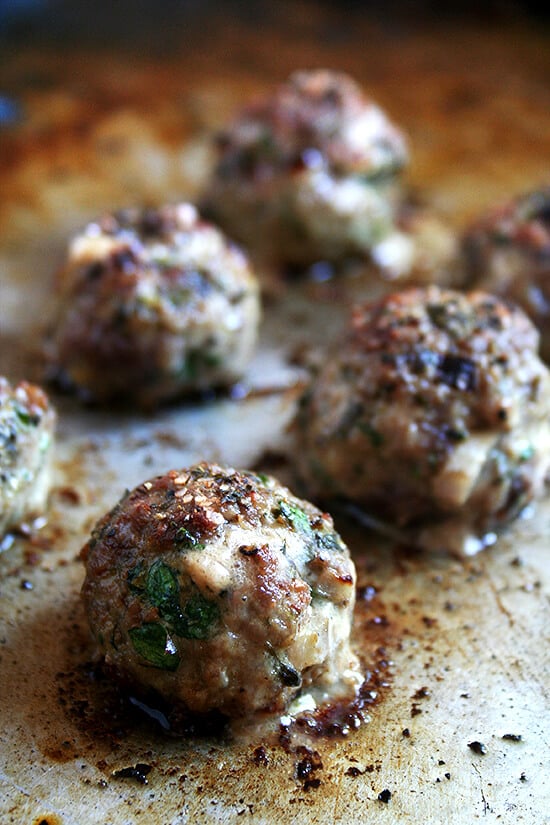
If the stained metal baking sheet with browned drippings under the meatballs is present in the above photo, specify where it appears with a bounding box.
[0,3,550,825]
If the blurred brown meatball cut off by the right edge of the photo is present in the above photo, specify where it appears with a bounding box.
[463,186,550,361]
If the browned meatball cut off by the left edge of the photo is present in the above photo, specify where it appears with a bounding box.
[0,378,55,535]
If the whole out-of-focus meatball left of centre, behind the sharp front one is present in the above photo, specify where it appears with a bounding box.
[52,203,259,406]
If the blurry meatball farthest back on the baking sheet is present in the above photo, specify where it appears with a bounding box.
[205,70,407,266]
